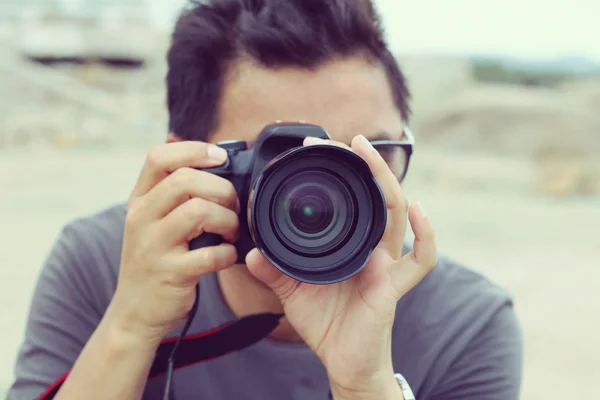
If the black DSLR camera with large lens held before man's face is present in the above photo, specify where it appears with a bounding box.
[190,123,387,284]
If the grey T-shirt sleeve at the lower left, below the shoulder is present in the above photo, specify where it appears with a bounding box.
[7,225,109,400]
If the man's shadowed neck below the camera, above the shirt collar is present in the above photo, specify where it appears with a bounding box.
[218,264,302,342]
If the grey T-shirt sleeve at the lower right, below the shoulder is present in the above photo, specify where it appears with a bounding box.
[431,303,523,400]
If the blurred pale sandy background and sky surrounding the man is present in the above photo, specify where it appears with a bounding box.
[0,0,600,400]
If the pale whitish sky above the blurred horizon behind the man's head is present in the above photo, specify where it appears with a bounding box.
[152,0,600,62]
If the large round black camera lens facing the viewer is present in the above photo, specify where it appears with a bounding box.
[248,145,387,284]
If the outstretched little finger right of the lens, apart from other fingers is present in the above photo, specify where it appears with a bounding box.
[391,203,437,298]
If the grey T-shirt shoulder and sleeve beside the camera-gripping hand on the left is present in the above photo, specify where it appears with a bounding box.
[8,206,125,399]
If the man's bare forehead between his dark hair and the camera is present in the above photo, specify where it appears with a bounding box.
[211,58,403,144]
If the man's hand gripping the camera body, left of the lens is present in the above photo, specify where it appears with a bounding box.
[107,142,240,345]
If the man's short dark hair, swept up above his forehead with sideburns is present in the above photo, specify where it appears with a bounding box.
[167,0,410,141]
